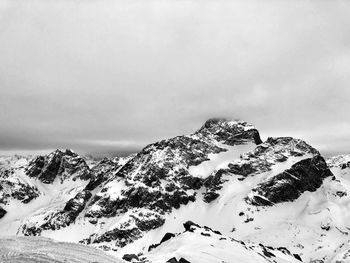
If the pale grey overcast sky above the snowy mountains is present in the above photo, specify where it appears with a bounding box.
[0,0,350,155]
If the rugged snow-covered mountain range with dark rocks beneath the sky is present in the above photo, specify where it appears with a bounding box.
[0,119,350,263]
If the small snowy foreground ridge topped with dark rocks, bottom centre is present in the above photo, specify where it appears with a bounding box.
[139,221,300,263]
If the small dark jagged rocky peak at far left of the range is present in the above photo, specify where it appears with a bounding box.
[26,150,92,184]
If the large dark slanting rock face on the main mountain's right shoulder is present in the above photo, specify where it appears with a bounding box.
[248,155,333,206]
